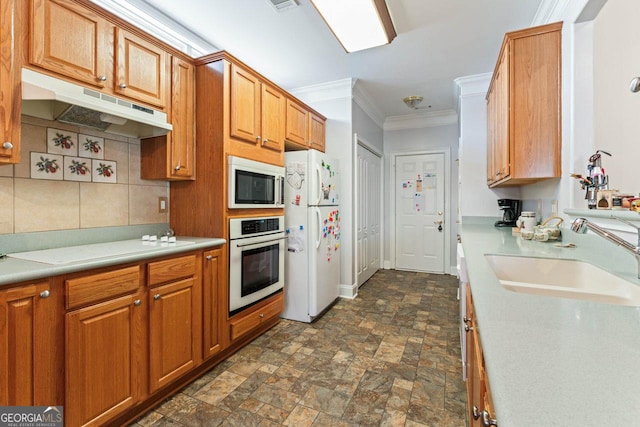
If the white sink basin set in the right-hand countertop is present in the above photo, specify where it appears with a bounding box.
[485,255,640,306]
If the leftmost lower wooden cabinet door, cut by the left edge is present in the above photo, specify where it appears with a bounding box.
[0,282,64,406]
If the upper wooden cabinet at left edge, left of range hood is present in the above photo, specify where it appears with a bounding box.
[0,0,22,165]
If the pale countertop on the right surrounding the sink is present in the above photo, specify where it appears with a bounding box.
[461,217,640,427]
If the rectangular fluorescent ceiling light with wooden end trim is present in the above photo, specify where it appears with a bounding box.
[311,0,396,52]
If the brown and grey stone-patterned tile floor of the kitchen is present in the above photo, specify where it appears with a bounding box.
[132,270,466,427]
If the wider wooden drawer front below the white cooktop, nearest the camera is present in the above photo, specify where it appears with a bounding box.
[65,266,140,309]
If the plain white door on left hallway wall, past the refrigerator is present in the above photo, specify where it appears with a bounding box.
[356,144,382,286]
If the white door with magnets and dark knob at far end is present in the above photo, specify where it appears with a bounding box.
[394,153,447,273]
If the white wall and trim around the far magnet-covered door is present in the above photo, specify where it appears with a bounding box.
[383,124,458,265]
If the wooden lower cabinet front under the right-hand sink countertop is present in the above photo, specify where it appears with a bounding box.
[465,285,498,427]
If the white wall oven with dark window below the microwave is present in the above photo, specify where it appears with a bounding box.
[229,216,286,316]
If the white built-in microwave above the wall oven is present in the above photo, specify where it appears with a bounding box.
[228,156,284,209]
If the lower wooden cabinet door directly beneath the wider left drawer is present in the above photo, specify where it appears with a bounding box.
[64,294,146,426]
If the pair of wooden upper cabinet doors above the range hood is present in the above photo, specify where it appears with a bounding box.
[29,0,171,109]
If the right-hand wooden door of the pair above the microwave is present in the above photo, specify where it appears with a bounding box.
[261,83,287,151]
